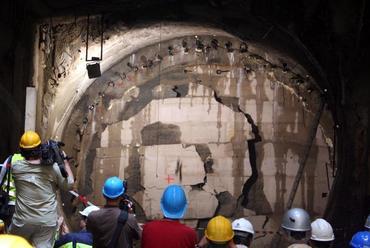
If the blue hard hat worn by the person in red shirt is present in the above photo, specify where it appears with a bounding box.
[161,184,188,219]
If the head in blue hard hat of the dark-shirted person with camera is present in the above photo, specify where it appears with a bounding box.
[102,177,126,206]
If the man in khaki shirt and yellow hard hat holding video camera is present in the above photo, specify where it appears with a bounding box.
[10,131,73,248]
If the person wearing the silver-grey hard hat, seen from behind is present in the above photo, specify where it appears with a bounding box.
[281,208,311,248]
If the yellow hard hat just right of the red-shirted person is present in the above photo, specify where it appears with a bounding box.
[205,215,234,243]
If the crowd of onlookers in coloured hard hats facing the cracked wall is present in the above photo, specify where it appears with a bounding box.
[0,131,370,248]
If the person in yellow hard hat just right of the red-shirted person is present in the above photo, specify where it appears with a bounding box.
[196,215,236,248]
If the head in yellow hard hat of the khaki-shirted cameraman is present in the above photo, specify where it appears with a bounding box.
[19,131,41,160]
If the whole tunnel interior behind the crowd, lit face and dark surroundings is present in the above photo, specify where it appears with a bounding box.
[0,0,370,247]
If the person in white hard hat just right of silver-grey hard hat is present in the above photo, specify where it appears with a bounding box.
[310,218,334,248]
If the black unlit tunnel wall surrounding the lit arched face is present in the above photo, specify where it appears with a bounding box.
[0,0,364,245]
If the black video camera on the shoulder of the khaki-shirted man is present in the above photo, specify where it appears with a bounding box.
[41,140,68,177]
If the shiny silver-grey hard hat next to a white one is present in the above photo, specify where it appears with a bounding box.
[281,208,311,232]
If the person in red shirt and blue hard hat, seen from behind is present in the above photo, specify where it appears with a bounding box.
[141,184,197,248]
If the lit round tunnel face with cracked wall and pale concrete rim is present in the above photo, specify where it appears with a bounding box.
[36,18,336,247]
